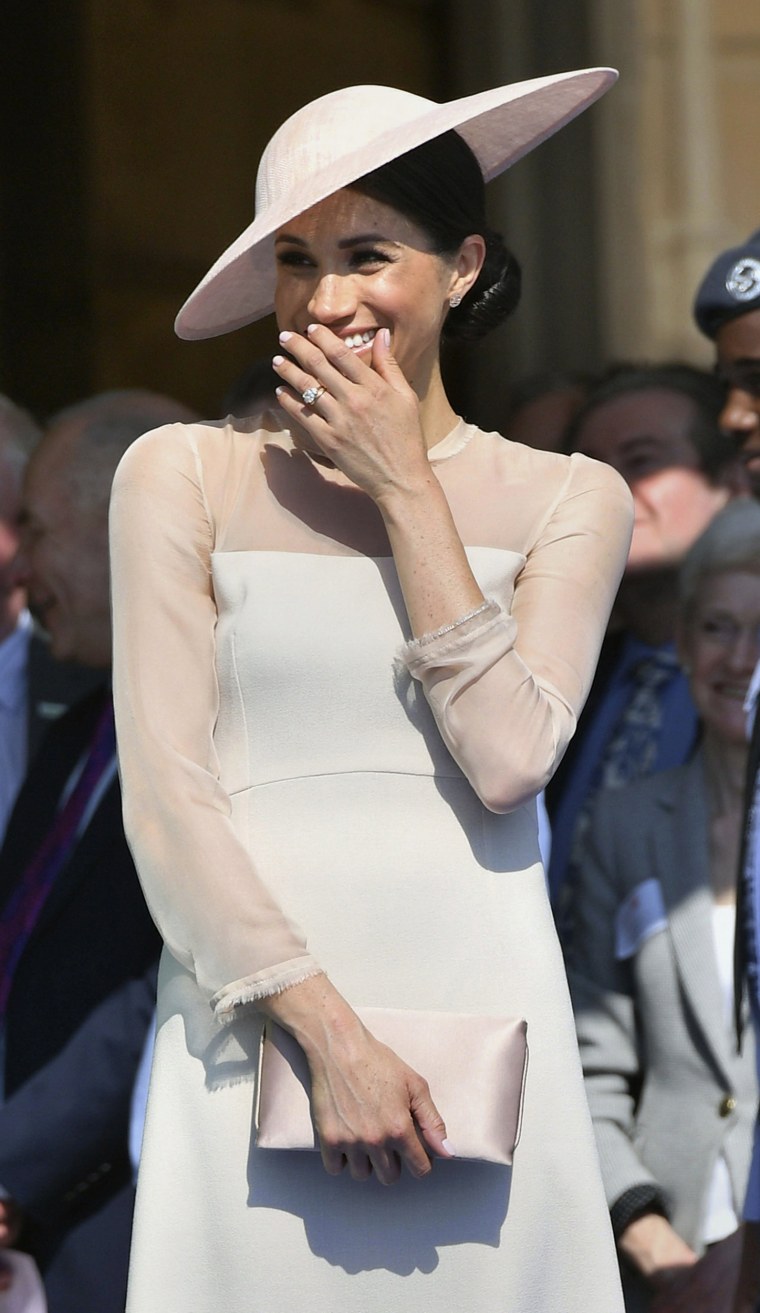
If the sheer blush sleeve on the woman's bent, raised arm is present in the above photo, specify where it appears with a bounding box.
[404,457,633,811]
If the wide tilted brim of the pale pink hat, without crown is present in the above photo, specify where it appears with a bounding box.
[175,68,617,340]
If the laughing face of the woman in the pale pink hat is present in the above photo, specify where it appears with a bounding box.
[274,188,482,397]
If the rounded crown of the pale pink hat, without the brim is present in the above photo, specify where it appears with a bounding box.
[256,85,436,214]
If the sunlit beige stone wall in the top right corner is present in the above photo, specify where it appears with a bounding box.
[593,0,760,361]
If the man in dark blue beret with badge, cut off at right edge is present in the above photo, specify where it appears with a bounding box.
[694,230,760,1313]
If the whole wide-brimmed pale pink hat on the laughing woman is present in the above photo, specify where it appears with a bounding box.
[175,68,617,339]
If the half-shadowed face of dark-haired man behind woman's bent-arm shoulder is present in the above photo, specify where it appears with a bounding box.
[575,387,728,572]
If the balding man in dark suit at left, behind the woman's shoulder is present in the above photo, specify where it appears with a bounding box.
[0,391,196,1313]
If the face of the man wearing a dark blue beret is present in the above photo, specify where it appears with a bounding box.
[715,310,760,498]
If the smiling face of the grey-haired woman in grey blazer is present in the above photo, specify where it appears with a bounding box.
[679,570,760,744]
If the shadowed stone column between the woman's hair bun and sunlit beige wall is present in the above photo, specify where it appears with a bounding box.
[449,0,617,428]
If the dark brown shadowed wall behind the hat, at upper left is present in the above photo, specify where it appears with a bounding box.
[85,0,442,414]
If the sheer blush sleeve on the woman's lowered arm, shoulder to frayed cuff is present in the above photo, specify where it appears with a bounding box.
[110,425,320,1015]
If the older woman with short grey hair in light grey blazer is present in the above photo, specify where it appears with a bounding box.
[568,500,760,1313]
